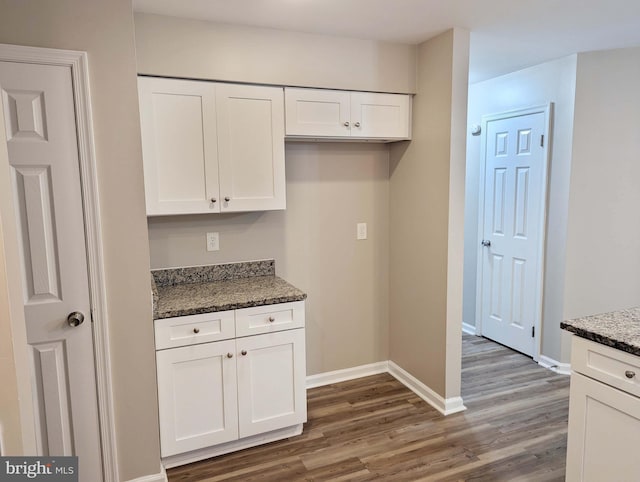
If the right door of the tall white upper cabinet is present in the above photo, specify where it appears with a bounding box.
[216,84,286,212]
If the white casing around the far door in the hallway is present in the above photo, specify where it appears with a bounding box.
[476,102,553,361]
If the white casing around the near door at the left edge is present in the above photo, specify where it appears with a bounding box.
[0,44,119,481]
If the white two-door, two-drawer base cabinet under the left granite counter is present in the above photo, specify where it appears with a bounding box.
[155,301,307,466]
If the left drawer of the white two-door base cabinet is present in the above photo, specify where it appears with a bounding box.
[155,311,235,350]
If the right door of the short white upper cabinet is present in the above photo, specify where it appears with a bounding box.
[351,92,411,139]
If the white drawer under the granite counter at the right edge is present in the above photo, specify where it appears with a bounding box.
[571,336,640,397]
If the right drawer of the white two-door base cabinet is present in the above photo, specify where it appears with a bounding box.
[236,301,304,336]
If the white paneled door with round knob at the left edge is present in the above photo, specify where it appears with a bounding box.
[0,62,102,481]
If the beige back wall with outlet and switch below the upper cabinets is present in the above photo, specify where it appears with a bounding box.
[148,143,389,375]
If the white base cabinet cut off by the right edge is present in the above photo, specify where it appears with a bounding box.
[566,336,640,482]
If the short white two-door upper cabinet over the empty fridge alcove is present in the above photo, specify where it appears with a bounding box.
[285,88,411,142]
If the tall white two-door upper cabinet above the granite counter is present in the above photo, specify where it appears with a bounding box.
[138,77,286,216]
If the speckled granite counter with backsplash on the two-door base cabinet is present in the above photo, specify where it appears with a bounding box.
[151,260,307,320]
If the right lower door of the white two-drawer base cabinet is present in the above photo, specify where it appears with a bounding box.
[236,329,307,437]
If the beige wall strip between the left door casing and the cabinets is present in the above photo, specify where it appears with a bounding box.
[0,0,160,480]
